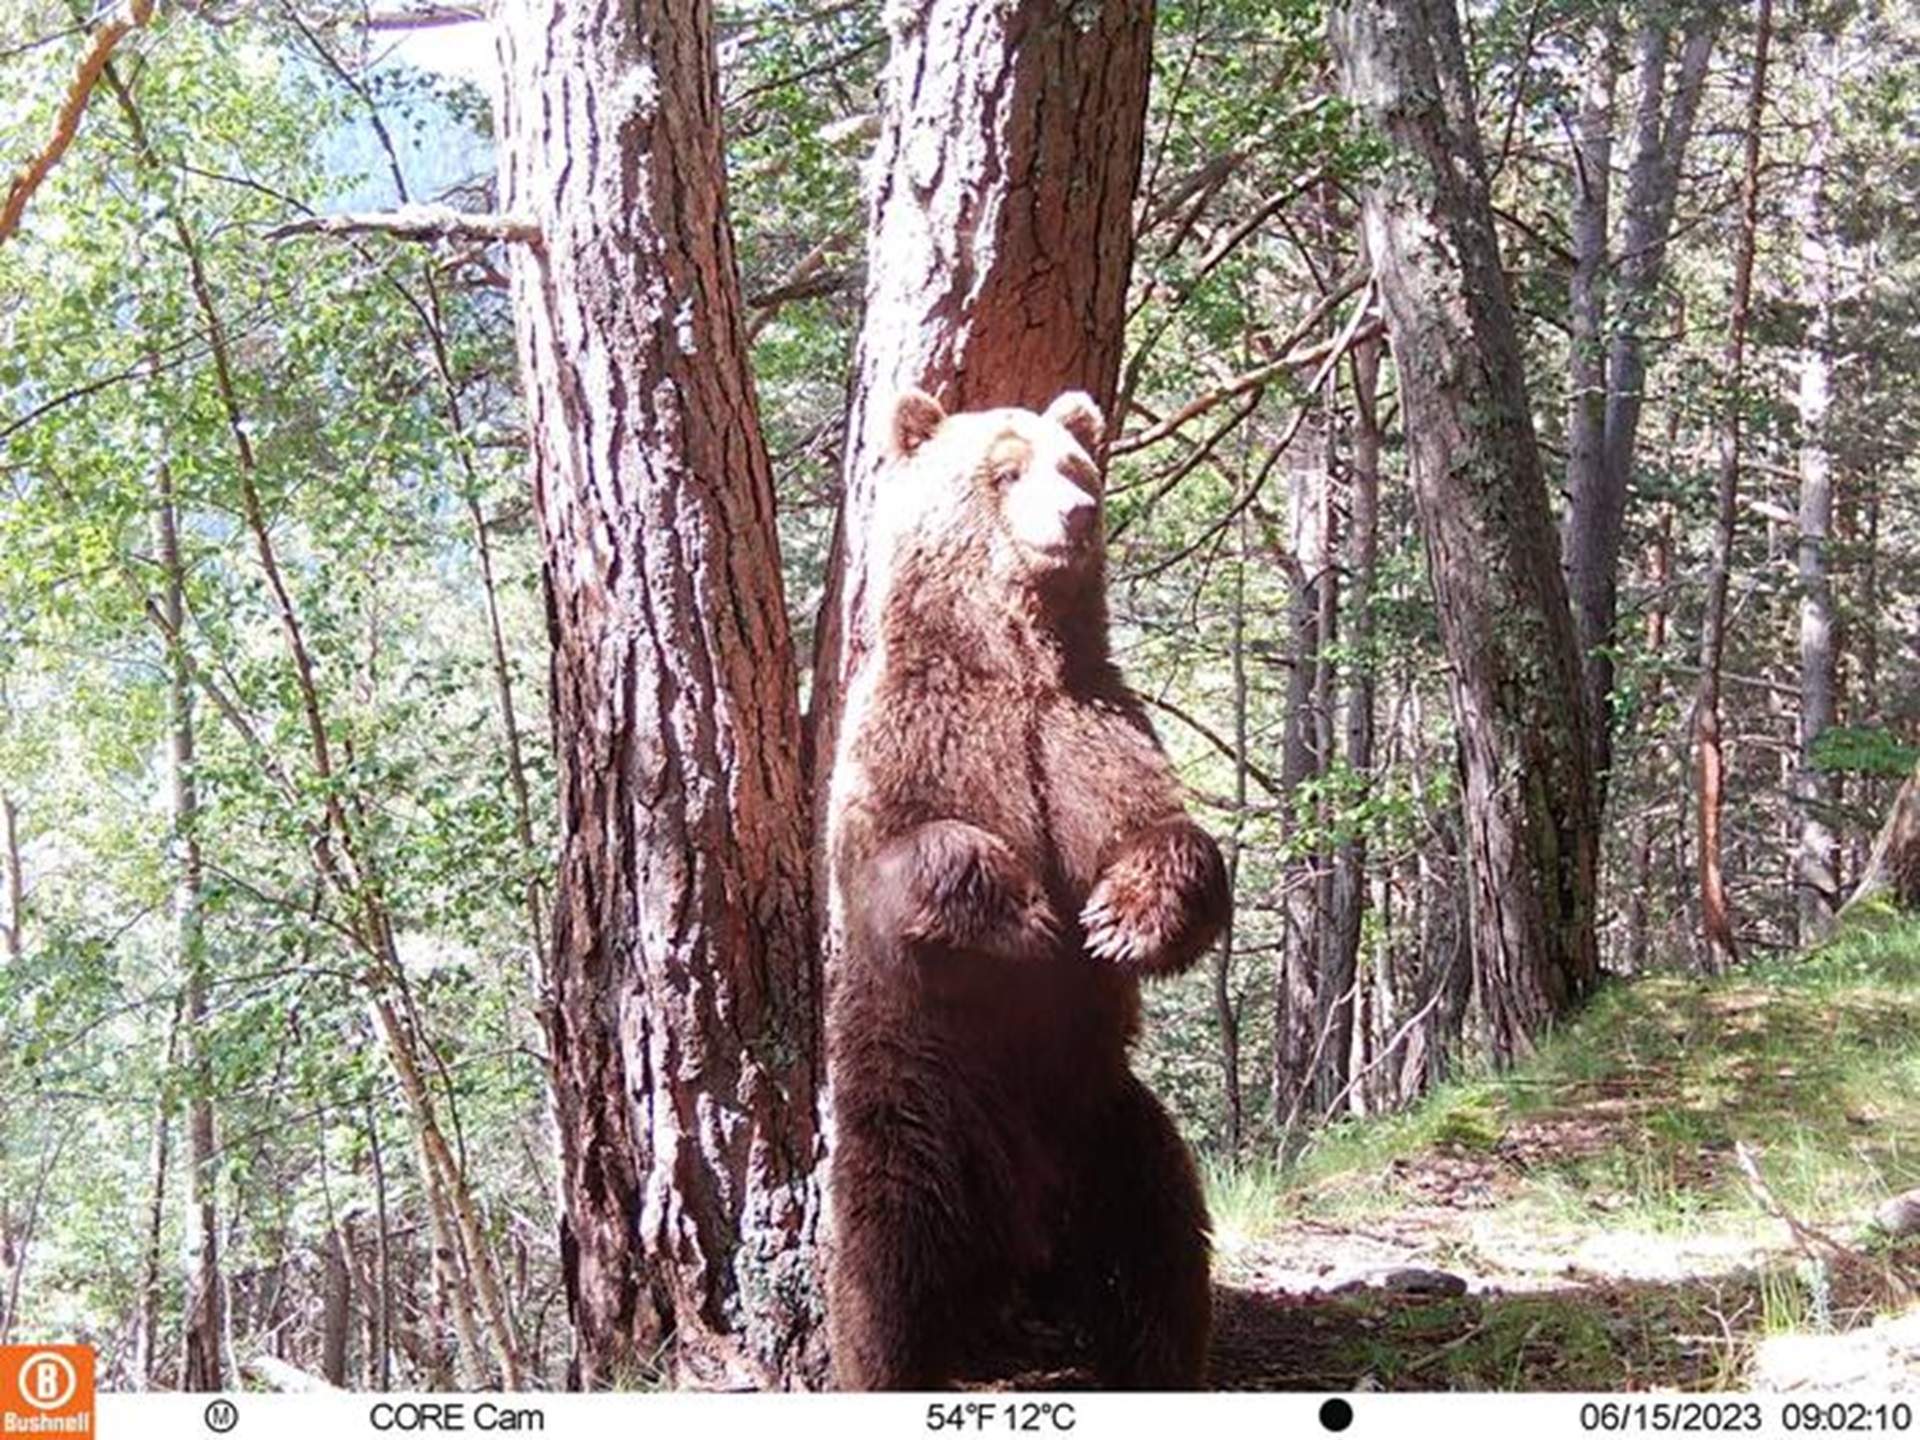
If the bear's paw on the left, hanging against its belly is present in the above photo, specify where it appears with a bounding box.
[883,820,1060,958]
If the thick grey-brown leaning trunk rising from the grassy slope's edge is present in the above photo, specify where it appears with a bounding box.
[1332,0,1597,1062]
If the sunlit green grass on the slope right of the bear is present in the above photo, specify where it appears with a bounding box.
[1210,916,1920,1246]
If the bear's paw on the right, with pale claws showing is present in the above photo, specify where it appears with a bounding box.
[1081,820,1231,973]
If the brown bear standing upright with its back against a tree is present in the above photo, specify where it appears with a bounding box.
[828,392,1229,1390]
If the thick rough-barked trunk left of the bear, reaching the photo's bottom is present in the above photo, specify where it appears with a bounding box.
[497,0,820,1386]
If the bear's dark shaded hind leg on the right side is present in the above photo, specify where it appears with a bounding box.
[1079,1075,1213,1390]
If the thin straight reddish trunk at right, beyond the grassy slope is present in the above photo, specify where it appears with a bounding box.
[1693,0,1774,973]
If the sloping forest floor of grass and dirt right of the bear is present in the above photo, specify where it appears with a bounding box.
[1210,927,1920,1390]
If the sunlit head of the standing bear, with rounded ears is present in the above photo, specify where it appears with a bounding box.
[870,390,1104,629]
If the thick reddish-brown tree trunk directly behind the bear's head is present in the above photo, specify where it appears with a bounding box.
[806,0,1154,814]
